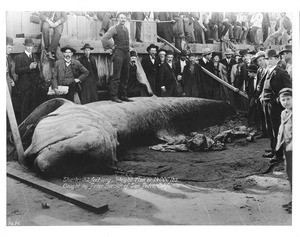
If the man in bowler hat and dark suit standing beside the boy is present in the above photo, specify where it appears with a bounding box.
[261,49,292,163]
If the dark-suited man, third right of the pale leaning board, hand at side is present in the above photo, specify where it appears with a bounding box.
[159,51,178,97]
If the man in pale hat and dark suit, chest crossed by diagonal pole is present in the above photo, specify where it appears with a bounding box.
[198,48,214,99]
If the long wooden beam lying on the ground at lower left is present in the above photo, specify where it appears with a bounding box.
[7,165,108,214]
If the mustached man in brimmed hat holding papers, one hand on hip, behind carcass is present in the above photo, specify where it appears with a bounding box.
[52,45,89,102]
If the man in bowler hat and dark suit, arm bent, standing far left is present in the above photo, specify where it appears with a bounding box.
[15,38,40,121]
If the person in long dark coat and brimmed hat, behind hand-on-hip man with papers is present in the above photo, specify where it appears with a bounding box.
[78,44,99,104]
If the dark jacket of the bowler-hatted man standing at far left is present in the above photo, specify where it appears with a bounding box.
[15,52,40,92]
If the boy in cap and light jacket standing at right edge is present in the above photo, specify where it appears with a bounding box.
[276,88,293,213]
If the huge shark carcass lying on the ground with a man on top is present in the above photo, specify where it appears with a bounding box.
[19,97,235,177]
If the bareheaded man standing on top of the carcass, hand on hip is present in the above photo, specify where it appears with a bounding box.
[101,12,131,103]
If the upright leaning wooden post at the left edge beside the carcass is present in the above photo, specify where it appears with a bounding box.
[6,84,25,165]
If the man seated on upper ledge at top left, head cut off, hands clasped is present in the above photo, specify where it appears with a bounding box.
[40,12,67,60]
